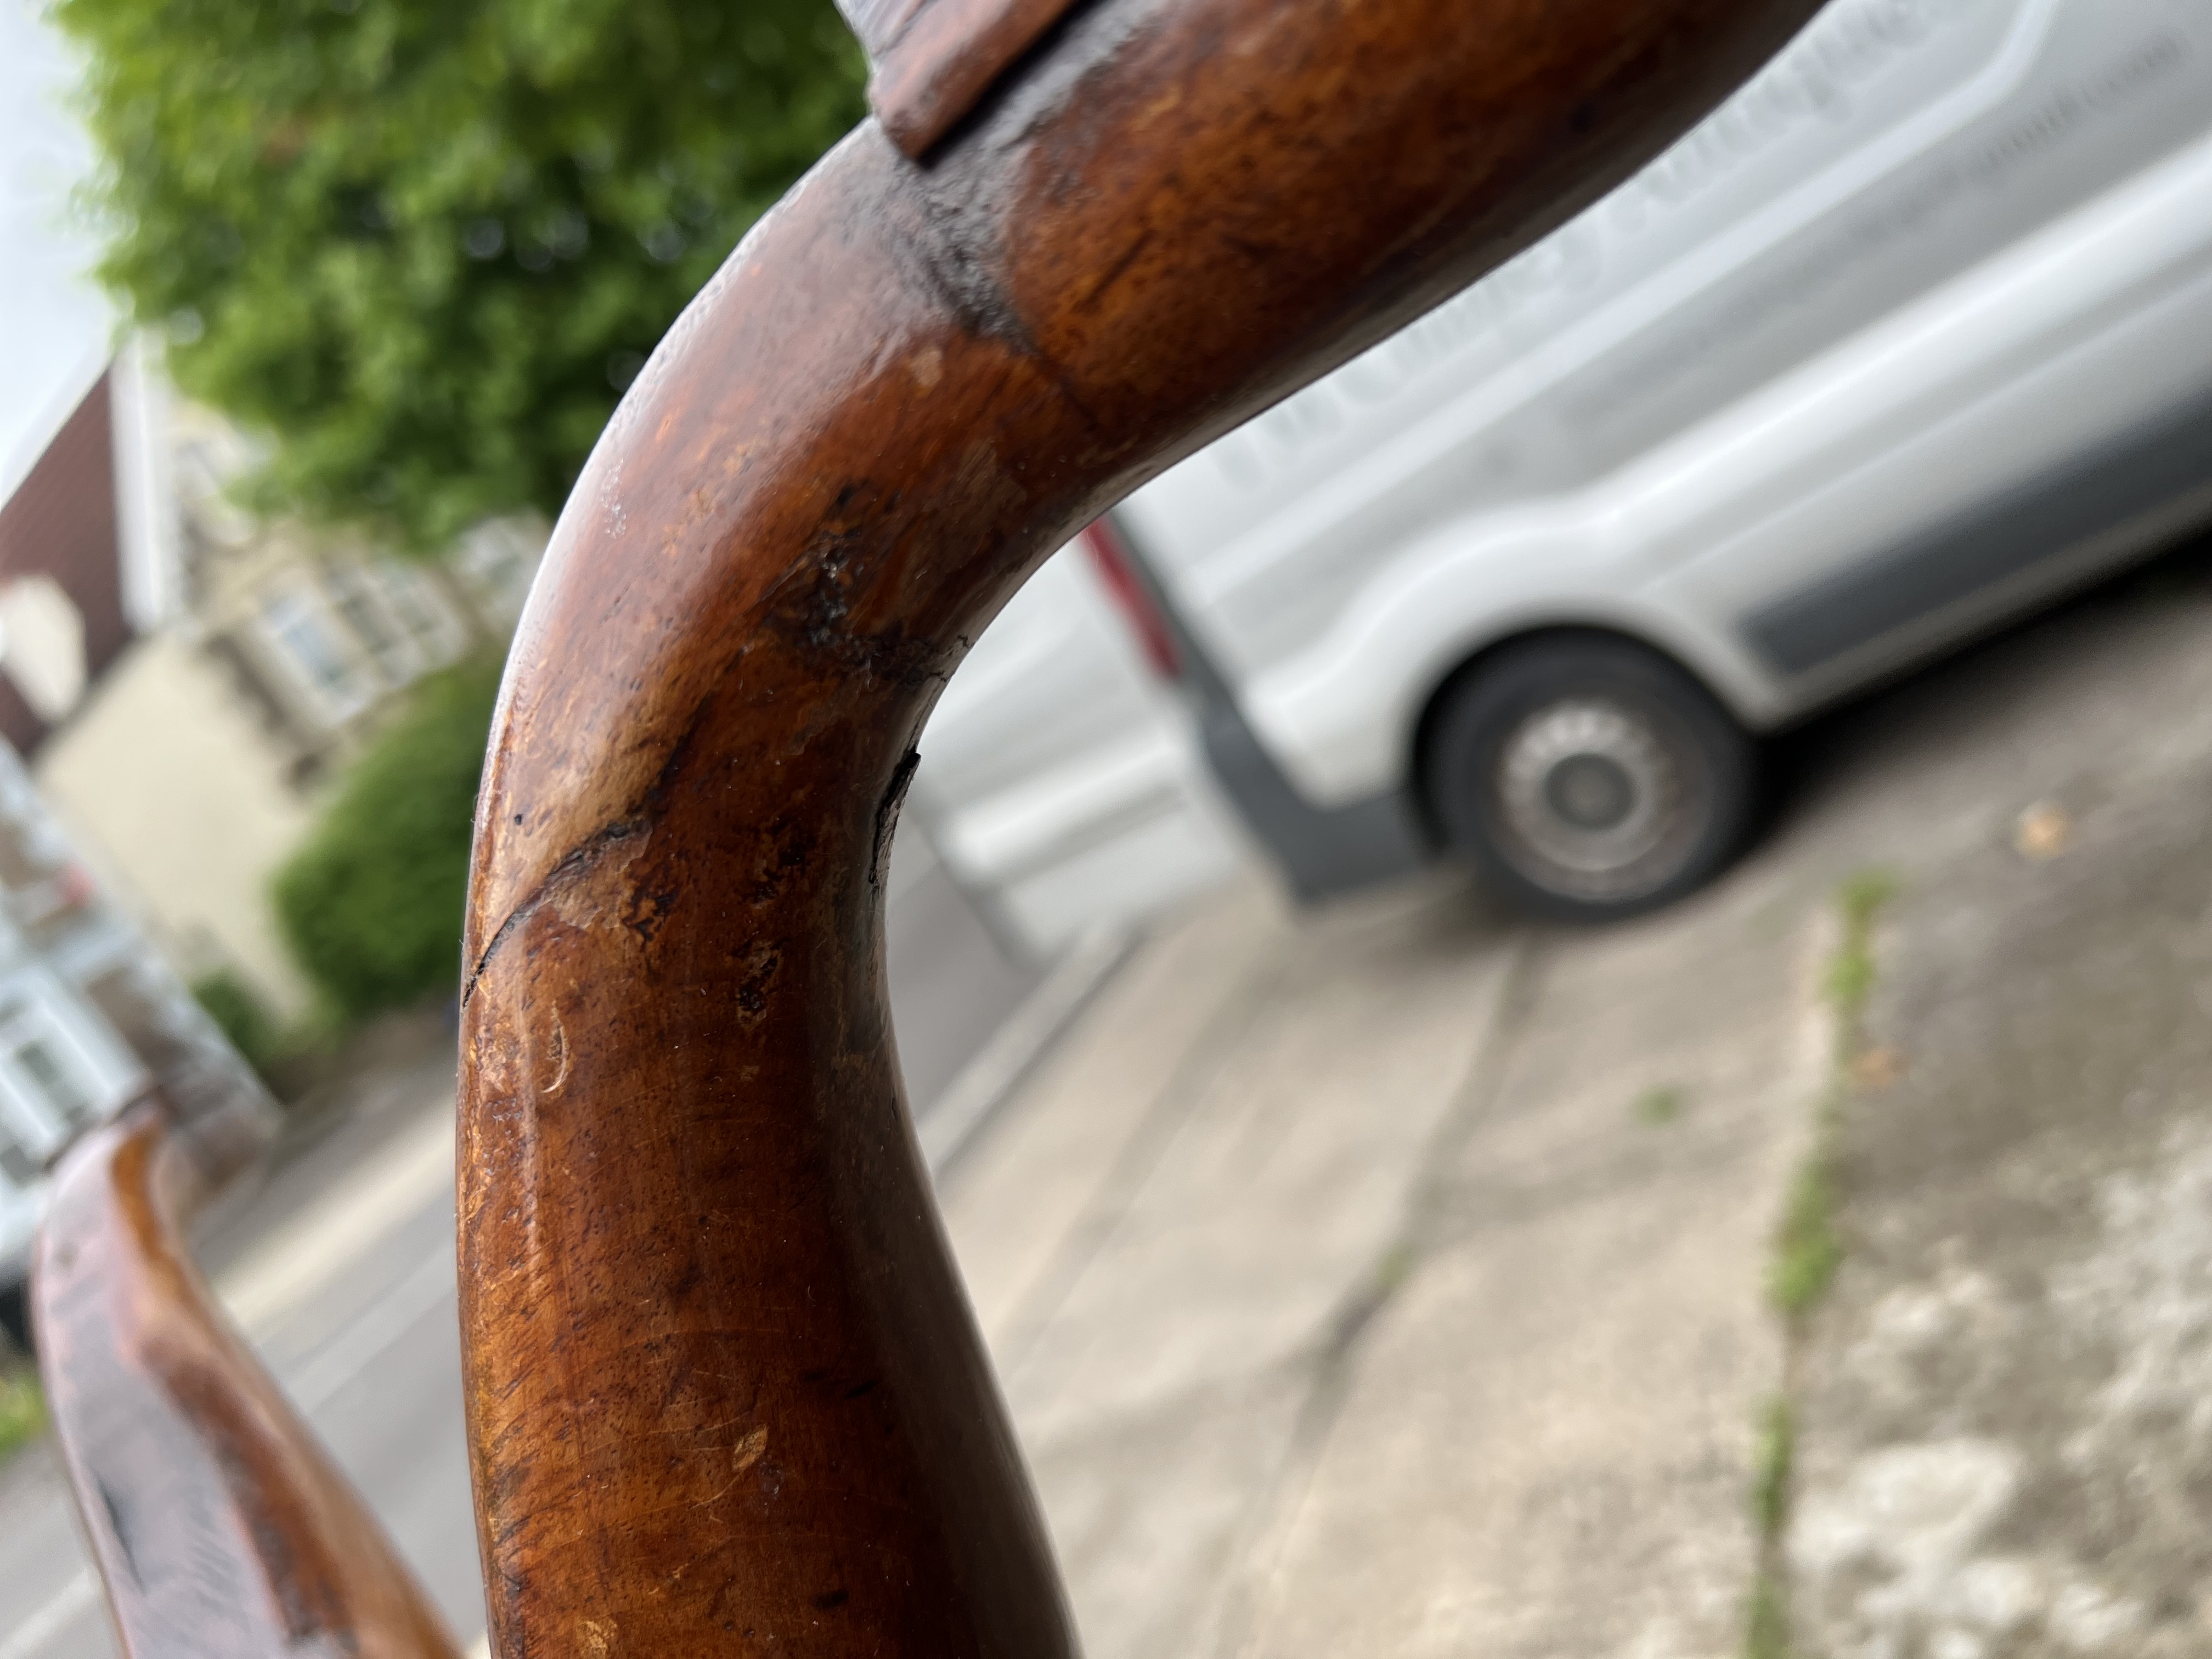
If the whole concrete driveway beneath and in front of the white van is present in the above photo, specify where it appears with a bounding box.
[940,533,2212,1659]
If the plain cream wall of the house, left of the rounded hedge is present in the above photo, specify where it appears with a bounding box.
[31,633,312,1018]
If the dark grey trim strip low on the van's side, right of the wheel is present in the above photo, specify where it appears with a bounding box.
[1741,396,2212,675]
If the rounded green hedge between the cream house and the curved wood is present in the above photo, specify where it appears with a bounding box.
[274,662,500,1022]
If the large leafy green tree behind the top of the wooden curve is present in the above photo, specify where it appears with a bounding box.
[53,0,862,546]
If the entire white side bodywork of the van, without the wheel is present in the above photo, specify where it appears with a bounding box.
[1121,0,2212,805]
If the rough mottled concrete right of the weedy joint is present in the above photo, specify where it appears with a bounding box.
[1790,757,2212,1659]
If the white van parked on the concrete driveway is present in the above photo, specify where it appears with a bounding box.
[907,0,2212,938]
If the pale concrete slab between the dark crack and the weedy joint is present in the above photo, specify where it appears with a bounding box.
[1241,862,1827,1659]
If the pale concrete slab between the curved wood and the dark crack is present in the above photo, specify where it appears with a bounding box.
[943,883,1517,1659]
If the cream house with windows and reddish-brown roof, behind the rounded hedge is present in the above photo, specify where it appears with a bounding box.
[0,354,544,1018]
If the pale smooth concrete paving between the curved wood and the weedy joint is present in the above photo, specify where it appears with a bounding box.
[943,845,1827,1659]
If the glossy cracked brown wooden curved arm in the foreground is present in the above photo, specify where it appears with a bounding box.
[460,0,1814,1659]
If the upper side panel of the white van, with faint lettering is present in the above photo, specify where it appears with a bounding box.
[1124,0,2212,681]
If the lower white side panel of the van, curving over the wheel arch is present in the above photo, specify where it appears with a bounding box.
[1243,128,2212,803]
